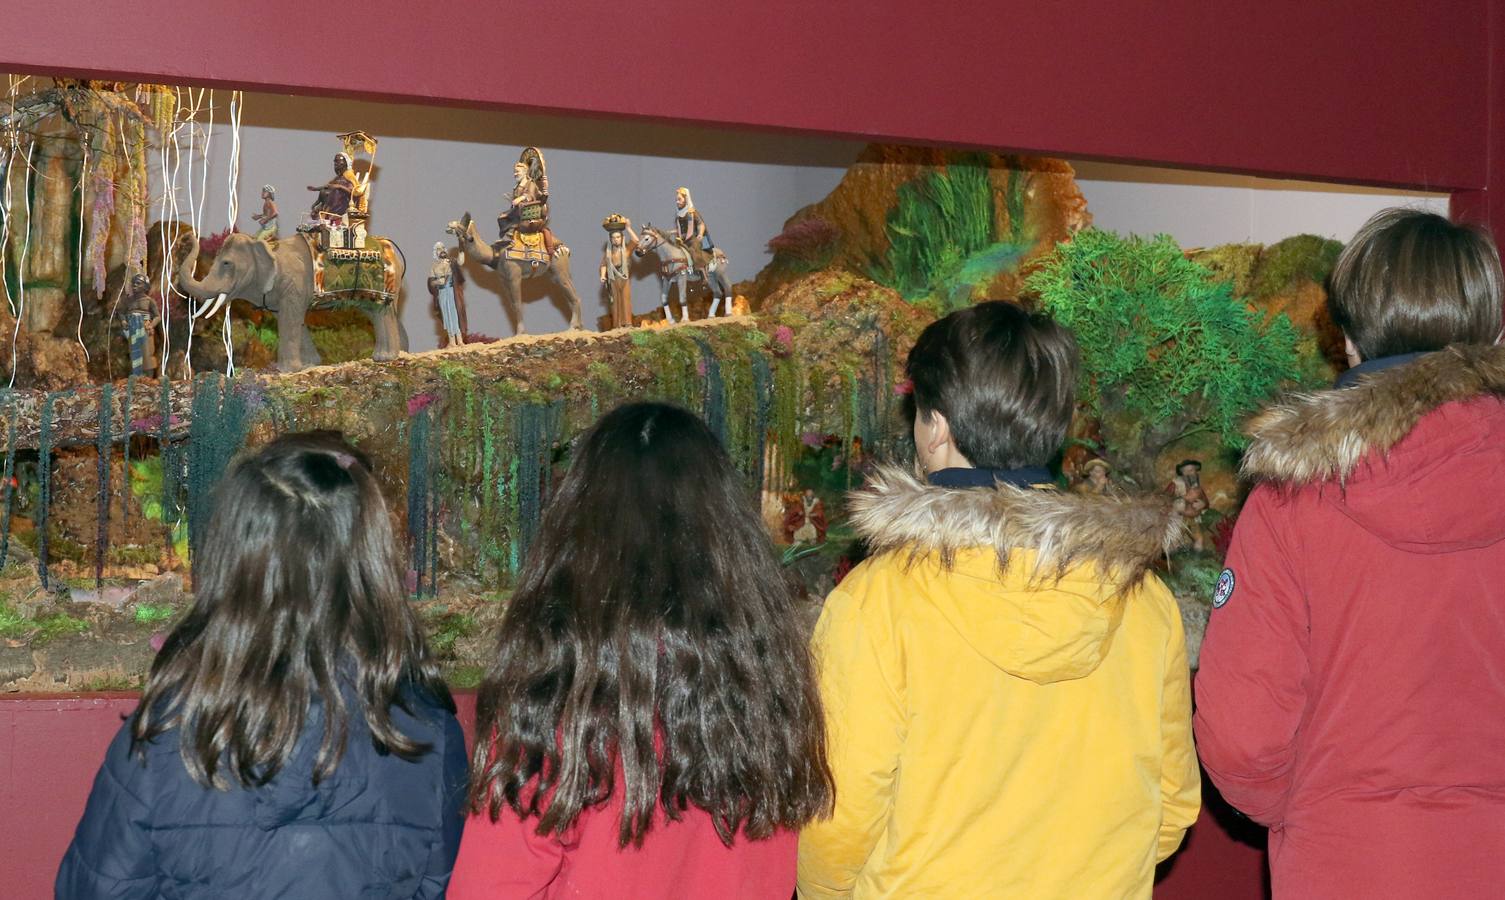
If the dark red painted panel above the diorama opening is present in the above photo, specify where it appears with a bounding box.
[0,0,1494,190]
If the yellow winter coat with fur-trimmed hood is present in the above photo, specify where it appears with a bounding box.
[799,470,1201,900]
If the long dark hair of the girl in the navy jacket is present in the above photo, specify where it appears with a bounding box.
[131,432,455,787]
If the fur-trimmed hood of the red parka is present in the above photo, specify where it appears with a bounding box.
[1243,345,1505,552]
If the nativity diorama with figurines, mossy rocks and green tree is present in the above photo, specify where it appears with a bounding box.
[0,77,1341,691]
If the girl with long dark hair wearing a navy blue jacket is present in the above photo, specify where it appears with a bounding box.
[57,432,465,900]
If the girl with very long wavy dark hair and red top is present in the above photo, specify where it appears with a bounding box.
[450,403,832,900]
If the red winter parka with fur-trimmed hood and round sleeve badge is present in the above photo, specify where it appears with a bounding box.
[1196,348,1505,900]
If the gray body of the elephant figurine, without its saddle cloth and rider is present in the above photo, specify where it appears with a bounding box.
[178,233,408,372]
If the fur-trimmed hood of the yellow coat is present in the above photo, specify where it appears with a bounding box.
[843,468,1183,683]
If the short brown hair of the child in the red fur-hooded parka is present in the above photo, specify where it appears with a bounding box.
[1327,208,1502,360]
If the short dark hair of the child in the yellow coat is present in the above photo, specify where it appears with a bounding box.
[906,299,1078,468]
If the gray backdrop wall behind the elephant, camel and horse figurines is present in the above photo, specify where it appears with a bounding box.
[176,92,862,349]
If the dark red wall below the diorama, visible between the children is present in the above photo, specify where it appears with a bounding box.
[0,692,1264,900]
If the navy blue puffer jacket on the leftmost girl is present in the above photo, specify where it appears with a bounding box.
[56,695,467,900]
